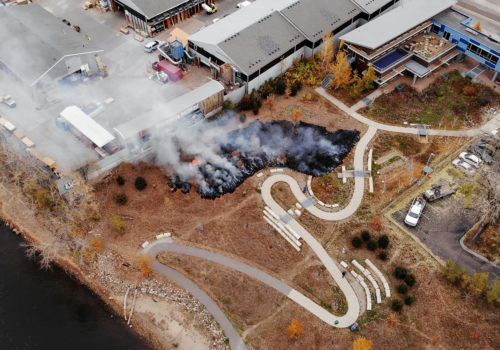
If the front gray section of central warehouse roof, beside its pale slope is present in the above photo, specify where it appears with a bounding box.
[218,12,304,74]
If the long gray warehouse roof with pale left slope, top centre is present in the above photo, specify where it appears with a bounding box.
[189,0,392,75]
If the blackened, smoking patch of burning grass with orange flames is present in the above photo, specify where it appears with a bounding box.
[170,121,359,199]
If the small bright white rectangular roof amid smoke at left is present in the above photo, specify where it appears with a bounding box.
[61,106,115,147]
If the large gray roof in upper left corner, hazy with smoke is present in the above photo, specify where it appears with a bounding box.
[0,4,102,85]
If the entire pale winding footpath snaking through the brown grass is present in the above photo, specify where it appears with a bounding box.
[145,88,500,350]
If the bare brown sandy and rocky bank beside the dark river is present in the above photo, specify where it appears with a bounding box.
[0,186,229,350]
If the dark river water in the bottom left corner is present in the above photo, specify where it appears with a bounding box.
[0,222,151,350]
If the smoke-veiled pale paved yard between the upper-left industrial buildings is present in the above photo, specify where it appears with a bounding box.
[0,0,244,172]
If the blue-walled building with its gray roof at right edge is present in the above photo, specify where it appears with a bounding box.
[431,9,500,80]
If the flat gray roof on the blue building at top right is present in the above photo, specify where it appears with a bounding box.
[434,8,500,52]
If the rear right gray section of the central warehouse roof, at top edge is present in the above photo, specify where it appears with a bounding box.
[281,0,360,42]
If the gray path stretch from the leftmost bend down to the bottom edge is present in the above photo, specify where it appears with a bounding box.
[145,240,247,350]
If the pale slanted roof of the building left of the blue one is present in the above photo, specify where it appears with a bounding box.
[340,0,456,49]
